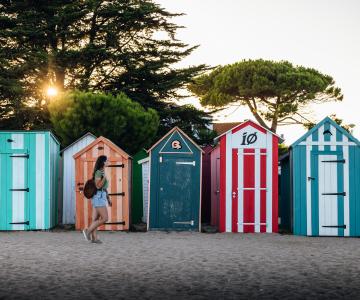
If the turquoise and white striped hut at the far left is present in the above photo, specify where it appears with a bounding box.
[0,131,60,230]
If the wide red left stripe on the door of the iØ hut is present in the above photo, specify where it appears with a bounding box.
[243,149,255,232]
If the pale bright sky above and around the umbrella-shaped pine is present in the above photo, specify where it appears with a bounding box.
[155,0,360,145]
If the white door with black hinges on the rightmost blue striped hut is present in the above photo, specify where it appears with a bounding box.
[318,155,346,236]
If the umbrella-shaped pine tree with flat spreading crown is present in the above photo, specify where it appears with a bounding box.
[188,59,343,132]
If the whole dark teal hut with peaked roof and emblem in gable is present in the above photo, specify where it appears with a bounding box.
[148,127,203,231]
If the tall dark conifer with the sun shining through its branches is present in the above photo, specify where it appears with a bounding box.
[0,0,205,136]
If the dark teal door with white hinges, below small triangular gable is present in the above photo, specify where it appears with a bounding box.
[158,156,198,229]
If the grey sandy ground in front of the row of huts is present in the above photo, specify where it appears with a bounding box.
[0,231,360,299]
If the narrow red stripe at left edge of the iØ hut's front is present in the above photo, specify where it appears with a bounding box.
[219,135,226,232]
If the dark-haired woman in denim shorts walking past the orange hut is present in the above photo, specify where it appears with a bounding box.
[83,155,112,244]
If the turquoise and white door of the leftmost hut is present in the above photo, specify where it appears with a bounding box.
[1,153,29,230]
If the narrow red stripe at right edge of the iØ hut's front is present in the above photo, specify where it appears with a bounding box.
[272,135,279,232]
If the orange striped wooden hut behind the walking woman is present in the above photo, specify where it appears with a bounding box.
[73,136,131,230]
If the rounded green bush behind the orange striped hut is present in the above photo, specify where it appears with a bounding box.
[49,91,159,154]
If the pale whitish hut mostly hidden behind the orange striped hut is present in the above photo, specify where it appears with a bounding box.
[60,132,96,224]
